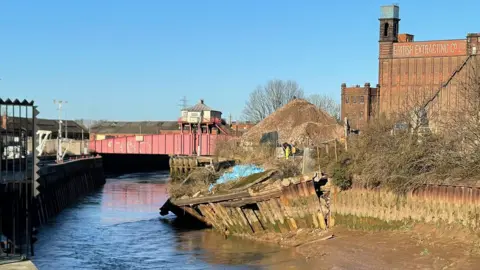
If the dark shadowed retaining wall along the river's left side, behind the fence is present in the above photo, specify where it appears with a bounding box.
[0,158,105,249]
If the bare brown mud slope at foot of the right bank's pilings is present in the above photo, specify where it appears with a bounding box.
[238,225,480,269]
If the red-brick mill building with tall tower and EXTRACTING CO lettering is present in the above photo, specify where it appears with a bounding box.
[342,5,480,130]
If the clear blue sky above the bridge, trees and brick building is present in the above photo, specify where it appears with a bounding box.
[0,0,480,120]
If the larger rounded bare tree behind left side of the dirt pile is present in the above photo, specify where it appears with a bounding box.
[243,80,304,122]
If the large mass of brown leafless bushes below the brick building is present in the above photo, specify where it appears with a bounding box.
[342,108,480,193]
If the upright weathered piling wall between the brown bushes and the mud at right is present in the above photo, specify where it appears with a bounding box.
[331,186,480,231]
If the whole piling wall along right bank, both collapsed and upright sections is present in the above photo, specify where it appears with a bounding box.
[174,178,480,234]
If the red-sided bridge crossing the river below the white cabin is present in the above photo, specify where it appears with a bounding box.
[90,133,228,156]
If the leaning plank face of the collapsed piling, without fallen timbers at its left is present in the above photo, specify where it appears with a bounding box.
[183,180,327,234]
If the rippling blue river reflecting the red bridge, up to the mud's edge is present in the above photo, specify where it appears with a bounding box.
[33,172,308,270]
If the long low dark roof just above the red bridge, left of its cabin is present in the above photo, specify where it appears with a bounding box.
[90,121,179,134]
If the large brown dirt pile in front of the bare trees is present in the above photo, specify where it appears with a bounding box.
[242,99,343,145]
